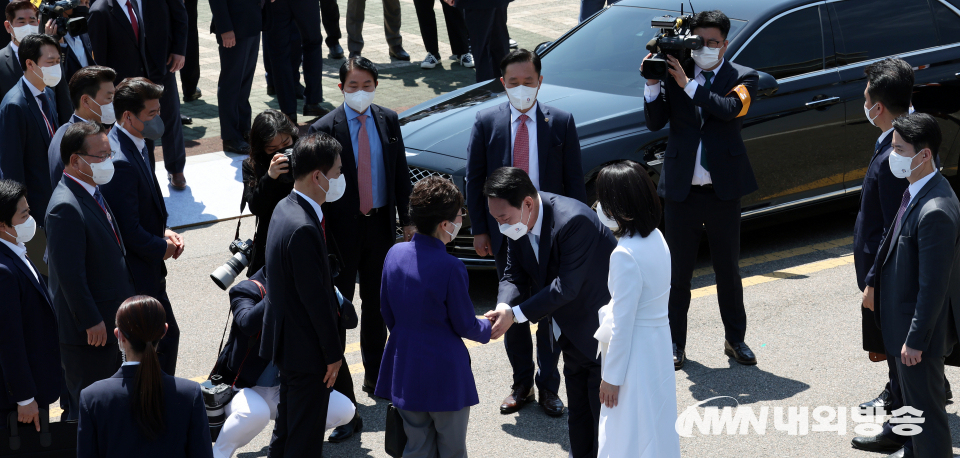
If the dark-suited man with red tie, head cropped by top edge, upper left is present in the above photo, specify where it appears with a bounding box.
[88,0,188,189]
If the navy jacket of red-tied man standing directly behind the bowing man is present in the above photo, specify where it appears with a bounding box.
[467,102,587,253]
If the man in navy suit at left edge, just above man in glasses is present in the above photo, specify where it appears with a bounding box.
[0,34,60,275]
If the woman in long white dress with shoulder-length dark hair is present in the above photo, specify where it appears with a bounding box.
[595,161,680,458]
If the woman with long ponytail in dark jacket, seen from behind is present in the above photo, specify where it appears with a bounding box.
[77,296,213,458]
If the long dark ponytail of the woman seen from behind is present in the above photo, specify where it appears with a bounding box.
[117,296,167,440]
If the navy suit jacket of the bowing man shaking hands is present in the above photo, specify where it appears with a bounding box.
[497,192,617,361]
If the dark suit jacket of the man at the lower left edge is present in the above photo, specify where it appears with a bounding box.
[0,243,63,416]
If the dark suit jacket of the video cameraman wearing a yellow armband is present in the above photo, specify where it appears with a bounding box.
[643,61,759,202]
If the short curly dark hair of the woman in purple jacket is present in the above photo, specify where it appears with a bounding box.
[410,176,463,235]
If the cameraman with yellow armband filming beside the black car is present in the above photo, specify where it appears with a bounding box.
[643,11,759,370]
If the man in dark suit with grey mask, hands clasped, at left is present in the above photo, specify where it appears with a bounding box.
[101,78,184,375]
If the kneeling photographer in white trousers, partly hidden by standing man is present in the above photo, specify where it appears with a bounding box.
[208,269,357,458]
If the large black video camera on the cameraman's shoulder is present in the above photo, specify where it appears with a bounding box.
[640,4,704,80]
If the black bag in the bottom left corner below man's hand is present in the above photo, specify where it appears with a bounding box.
[0,409,77,458]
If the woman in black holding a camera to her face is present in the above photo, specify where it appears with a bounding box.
[242,110,299,276]
